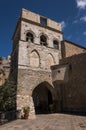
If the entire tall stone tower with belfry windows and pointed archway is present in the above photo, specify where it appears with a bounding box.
[12,9,62,115]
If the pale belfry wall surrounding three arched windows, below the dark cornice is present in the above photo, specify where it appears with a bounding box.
[21,21,62,50]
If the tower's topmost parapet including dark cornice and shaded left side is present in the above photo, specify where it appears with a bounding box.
[12,8,63,39]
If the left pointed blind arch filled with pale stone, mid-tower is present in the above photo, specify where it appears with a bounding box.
[30,50,40,67]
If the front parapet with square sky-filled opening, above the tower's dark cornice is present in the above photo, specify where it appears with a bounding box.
[21,8,61,31]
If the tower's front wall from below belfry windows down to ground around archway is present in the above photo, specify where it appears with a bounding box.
[17,41,59,116]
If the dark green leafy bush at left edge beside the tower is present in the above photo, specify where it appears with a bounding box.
[0,76,16,112]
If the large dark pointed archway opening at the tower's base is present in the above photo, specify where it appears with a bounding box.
[32,82,54,114]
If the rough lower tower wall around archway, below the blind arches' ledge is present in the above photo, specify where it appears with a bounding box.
[17,69,53,115]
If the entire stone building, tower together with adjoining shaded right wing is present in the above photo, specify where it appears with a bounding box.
[11,9,86,117]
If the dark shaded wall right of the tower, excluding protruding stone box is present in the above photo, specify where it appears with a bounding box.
[60,53,86,113]
